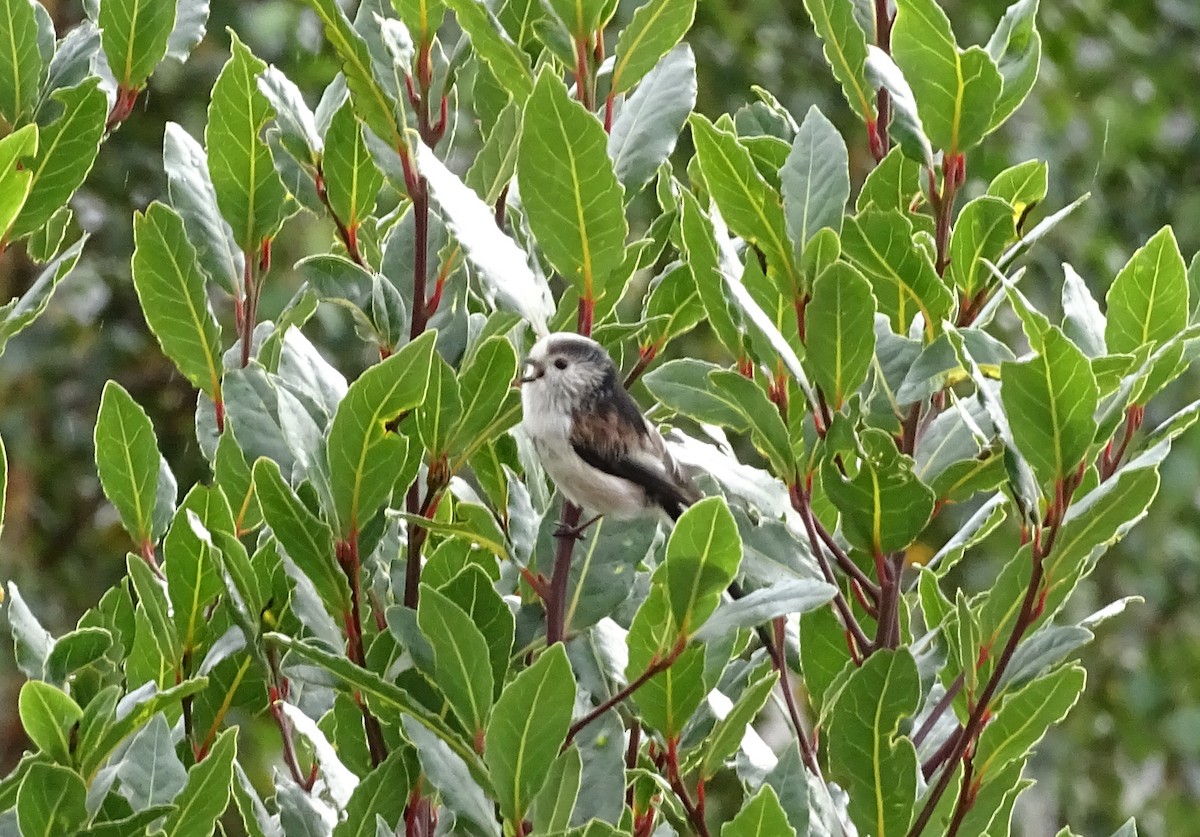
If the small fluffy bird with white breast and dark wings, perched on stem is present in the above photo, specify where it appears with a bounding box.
[521,332,701,525]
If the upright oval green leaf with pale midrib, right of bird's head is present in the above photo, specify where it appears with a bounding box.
[804,261,875,410]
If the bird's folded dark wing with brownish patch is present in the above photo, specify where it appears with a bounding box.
[571,387,700,519]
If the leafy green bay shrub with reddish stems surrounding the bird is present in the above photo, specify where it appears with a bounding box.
[0,0,1200,835]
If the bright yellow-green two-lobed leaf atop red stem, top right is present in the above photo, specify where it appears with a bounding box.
[892,0,1015,153]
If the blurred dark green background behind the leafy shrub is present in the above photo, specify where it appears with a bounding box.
[0,0,1200,835]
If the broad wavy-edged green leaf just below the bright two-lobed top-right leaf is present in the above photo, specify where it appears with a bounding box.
[841,207,954,336]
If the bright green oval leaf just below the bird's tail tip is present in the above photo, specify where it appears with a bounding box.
[654,496,742,637]
